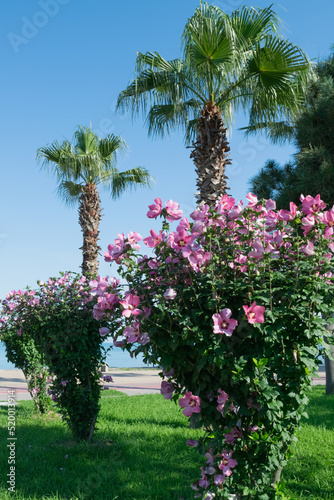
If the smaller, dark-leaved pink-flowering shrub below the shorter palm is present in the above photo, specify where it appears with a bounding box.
[1,273,109,440]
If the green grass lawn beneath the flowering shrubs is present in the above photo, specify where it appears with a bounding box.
[0,387,334,500]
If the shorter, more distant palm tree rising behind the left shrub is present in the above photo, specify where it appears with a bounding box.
[37,127,153,275]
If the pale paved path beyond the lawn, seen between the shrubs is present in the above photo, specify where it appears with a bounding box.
[0,367,326,401]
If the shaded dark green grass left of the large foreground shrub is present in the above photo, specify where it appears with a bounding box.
[0,398,202,500]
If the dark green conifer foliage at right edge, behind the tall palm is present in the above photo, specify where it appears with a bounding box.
[250,49,334,209]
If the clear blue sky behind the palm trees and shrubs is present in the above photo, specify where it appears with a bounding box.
[0,0,334,298]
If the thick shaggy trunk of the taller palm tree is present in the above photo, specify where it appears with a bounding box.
[190,102,231,205]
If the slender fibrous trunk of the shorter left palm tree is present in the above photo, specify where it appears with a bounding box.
[79,183,102,276]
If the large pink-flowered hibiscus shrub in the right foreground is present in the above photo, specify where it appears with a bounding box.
[93,193,334,500]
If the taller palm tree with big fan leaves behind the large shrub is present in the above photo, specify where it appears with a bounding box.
[117,3,310,204]
